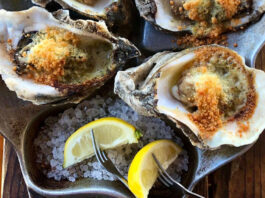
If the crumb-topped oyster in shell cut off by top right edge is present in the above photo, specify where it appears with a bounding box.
[135,0,265,37]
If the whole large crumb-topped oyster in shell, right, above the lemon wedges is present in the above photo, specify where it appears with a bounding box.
[114,45,265,149]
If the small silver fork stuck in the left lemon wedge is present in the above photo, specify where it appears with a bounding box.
[90,129,129,189]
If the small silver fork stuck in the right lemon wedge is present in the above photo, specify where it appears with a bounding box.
[152,153,205,198]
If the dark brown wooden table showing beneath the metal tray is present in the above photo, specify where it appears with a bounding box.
[2,48,265,198]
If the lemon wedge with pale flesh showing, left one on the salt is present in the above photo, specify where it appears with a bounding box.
[63,117,141,168]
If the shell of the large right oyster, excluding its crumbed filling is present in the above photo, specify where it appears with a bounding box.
[114,45,265,149]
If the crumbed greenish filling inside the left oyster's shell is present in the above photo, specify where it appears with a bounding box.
[15,27,112,86]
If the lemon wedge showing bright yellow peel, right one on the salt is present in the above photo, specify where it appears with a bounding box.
[128,140,181,198]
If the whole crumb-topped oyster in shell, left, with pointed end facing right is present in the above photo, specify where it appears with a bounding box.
[0,7,139,104]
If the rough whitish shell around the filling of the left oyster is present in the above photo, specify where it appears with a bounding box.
[0,7,139,105]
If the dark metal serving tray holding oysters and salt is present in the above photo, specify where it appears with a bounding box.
[0,0,265,198]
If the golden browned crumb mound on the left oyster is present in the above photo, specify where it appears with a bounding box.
[22,28,87,85]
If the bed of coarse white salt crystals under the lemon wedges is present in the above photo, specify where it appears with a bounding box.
[34,96,188,182]
